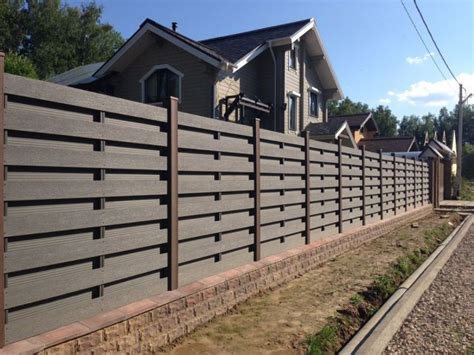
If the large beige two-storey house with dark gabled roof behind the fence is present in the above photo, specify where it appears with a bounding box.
[51,19,343,134]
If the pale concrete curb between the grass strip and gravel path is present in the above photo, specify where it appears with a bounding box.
[339,215,474,355]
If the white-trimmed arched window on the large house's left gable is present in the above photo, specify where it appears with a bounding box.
[140,64,183,105]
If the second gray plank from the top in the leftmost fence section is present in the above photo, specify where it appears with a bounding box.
[5,109,167,146]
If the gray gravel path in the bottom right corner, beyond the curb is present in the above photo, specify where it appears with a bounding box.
[385,225,474,354]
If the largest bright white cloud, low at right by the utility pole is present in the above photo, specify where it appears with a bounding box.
[388,73,474,107]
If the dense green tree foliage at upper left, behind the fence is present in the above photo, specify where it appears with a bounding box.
[0,0,123,79]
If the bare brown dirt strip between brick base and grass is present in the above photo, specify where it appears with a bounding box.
[165,215,460,355]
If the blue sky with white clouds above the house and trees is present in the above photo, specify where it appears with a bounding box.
[67,0,474,119]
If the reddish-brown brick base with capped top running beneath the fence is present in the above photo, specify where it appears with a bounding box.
[0,205,433,354]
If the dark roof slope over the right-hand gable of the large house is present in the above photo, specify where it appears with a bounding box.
[200,19,311,63]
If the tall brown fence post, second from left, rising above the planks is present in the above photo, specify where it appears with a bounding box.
[168,97,179,290]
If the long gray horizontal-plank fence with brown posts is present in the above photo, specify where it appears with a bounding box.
[0,63,430,343]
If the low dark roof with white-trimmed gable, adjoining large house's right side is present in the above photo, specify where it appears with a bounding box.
[305,119,357,149]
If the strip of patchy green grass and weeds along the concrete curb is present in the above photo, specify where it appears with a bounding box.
[306,222,460,355]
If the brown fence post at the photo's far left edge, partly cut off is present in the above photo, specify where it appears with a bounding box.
[0,52,5,347]
